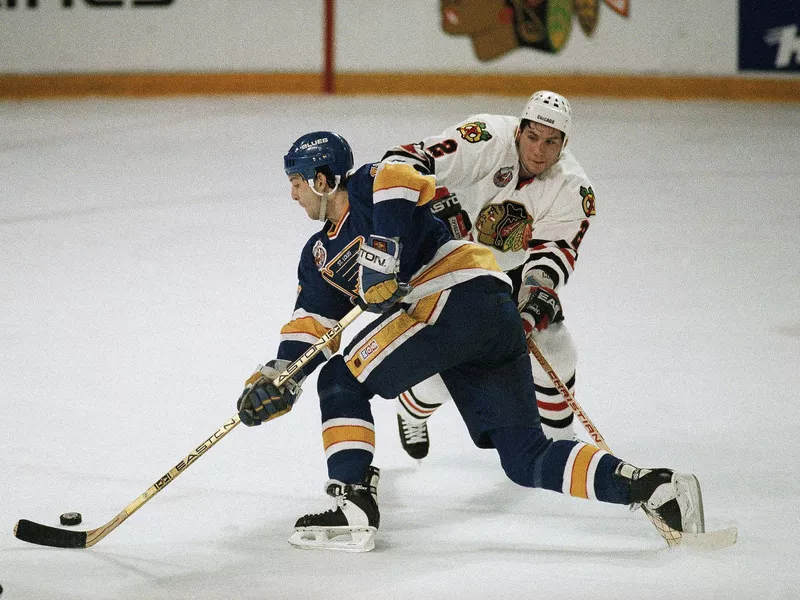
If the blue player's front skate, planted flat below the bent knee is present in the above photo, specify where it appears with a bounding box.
[289,467,380,552]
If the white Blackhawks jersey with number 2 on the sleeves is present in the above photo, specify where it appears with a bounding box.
[384,114,595,289]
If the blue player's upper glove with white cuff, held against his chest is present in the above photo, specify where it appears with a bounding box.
[358,235,411,313]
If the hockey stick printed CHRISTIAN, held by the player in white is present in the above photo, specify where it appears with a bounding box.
[526,335,738,550]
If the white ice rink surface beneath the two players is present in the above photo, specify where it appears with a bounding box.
[0,96,800,600]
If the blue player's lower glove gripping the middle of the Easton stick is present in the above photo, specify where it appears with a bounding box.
[236,359,305,427]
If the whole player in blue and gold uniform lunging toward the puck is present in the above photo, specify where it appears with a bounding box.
[237,131,704,551]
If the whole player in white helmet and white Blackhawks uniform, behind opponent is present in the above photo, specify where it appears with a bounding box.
[384,91,595,459]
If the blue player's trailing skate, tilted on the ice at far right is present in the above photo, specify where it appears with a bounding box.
[614,463,705,543]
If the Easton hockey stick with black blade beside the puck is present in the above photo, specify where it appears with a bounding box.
[14,306,364,548]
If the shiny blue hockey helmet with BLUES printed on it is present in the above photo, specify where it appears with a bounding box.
[283,131,353,182]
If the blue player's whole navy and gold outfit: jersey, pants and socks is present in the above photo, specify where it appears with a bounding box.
[278,163,630,516]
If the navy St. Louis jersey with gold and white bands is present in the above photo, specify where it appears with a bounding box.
[278,163,507,373]
